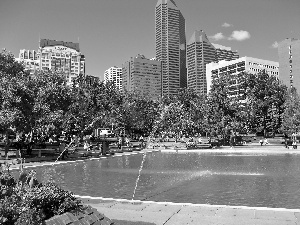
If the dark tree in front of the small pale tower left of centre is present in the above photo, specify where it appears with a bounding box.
[63,77,123,133]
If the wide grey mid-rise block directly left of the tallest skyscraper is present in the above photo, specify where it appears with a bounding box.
[122,55,162,100]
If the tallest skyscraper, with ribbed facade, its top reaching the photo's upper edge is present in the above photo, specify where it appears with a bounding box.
[155,0,187,95]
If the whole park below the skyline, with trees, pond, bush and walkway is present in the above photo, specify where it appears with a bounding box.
[0,48,300,224]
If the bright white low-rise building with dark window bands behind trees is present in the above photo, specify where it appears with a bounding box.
[206,56,279,94]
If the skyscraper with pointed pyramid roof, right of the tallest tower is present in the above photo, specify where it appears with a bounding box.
[187,30,216,95]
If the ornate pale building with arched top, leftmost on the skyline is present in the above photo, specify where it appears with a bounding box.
[16,39,85,84]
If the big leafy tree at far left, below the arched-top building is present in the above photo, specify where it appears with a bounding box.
[0,51,70,137]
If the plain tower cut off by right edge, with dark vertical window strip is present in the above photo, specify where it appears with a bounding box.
[278,38,300,90]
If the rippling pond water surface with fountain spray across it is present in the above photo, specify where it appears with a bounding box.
[23,152,300,208]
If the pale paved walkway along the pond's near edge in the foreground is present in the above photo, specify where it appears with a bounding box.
[82,197,300,225]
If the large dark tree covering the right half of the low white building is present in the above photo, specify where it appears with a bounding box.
[241,70,287,135]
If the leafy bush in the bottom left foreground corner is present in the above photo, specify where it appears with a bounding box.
[0,163,84,225]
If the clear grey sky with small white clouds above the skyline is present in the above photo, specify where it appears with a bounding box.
[0,0,300,80]
